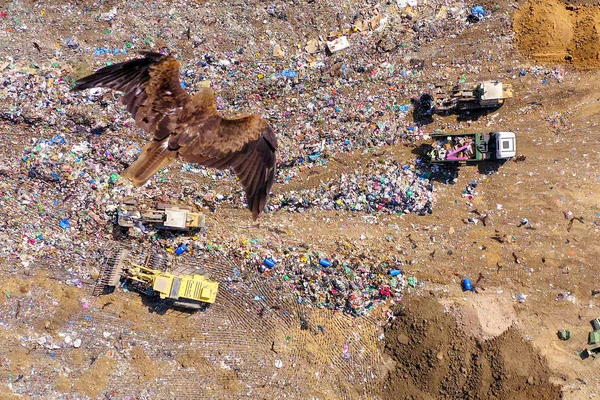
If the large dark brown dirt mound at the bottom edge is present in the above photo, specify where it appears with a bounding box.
[383,298,561,399]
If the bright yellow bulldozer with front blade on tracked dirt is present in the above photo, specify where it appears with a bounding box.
[93,249,219,310]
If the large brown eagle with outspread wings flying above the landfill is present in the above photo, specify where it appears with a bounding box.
[73,52,277,220]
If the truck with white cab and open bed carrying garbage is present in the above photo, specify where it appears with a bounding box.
[427,132,517,163]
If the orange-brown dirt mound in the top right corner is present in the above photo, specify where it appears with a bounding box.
[514,0,600,68]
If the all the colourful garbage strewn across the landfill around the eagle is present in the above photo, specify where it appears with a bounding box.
[0,1,516,322]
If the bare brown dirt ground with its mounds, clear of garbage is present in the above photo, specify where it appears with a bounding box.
[0,0,600,400]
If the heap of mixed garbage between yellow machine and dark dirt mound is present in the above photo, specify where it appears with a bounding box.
[207,233,418,317]
